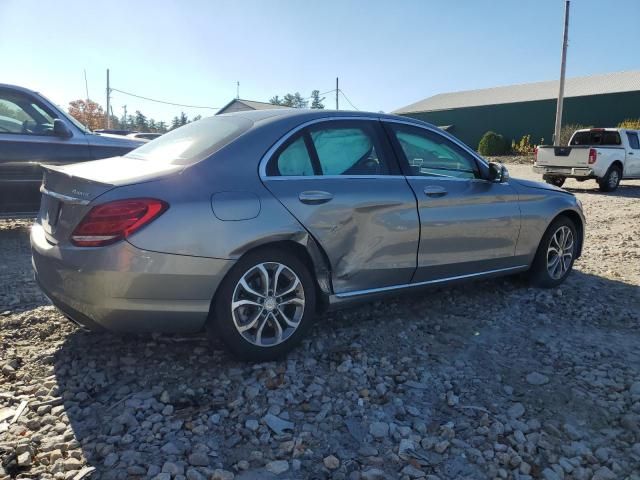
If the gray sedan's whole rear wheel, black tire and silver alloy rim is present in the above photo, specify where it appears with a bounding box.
[207,248,316,361]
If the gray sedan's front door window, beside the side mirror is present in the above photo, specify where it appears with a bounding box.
[391,125,480,178]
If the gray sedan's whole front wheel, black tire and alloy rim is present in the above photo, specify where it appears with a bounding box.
[529,216,578,288]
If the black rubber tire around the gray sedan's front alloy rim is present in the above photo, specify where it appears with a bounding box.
[528,216,579,288]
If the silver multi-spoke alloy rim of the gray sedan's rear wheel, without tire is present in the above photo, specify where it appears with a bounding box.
[231,262,305,347]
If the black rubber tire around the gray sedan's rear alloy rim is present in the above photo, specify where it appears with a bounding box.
[207,247,316,362]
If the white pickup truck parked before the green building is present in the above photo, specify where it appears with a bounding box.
[533,128,640,192]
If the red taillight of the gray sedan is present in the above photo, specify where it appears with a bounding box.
[71,198,169,247]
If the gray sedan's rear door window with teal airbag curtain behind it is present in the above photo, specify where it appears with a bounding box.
[310,122,389,175]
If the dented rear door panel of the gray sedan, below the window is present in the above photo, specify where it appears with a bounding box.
[265,176,419,293]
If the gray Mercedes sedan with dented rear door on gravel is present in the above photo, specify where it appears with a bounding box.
[31,109,584,360]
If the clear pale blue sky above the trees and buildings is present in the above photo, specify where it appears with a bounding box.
[0,0,640,122]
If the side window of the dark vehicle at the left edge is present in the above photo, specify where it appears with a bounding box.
[0,91,53,135]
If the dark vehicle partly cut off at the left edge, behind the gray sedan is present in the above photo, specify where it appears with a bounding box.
[0,84,142,216]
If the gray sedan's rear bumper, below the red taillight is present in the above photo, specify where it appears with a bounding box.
[31,223,233,333]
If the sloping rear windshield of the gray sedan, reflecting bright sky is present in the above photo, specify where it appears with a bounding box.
[125,116,253,165]
